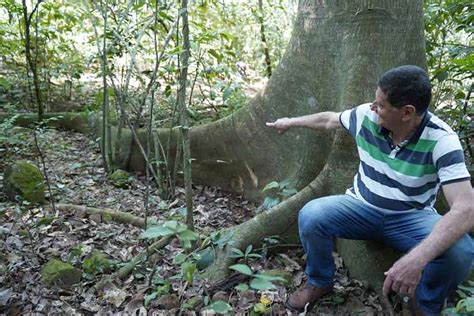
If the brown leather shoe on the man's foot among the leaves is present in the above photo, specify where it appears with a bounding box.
[285,284,332,313]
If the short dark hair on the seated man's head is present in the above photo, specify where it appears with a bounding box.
[378,65,431,115]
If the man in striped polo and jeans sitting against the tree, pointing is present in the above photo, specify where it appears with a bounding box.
[267,65,474,315]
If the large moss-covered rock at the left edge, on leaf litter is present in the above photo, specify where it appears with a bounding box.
[3,161,45,205]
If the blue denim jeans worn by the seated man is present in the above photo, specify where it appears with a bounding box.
[298,195,474,314]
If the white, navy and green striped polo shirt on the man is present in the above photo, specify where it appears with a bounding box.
[339,103,470,211]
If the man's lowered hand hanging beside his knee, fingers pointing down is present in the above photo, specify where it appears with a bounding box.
[383,254,426,296]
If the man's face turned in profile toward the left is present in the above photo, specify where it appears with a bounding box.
[370,88,402,131]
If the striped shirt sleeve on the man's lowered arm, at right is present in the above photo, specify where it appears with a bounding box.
[433,133,471,184]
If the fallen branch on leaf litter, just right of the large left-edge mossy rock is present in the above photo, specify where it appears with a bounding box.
[45,204,145,228]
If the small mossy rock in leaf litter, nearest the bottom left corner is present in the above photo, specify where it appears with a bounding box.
[41,259,82,288]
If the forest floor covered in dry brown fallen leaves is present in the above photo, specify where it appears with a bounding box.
[0,129,384,315]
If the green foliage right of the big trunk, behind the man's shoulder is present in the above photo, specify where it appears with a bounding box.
[425,0,474,171]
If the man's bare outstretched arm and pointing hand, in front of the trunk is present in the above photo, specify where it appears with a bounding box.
[267,112,342,133]
